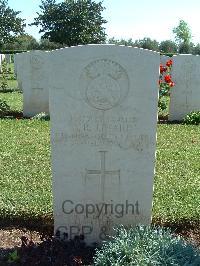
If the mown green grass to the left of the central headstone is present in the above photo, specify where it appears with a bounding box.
[0,119,52,221]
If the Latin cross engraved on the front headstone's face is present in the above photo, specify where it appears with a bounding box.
[86,151,120,200]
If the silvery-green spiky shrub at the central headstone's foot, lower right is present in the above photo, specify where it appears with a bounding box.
[94,226,200,266]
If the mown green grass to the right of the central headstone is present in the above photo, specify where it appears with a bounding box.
[153,125,200,223]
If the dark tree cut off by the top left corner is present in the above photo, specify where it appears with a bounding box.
[0,0,25,47]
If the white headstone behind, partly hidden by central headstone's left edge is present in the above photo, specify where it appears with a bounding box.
[15,51,49,117]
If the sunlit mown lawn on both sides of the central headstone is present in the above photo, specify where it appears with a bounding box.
[0,120,200,225]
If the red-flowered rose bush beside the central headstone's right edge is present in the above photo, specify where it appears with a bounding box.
[159,59,175,98]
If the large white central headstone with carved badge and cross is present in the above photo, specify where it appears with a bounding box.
[46,45,160,244]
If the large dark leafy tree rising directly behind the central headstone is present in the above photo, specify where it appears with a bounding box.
[30,0,106,46]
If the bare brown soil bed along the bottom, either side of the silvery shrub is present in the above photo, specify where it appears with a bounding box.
[0,224,200,266]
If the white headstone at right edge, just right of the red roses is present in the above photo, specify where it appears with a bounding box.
[169,55,200,121]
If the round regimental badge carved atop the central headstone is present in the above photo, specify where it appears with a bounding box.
[80,59,129,111]
